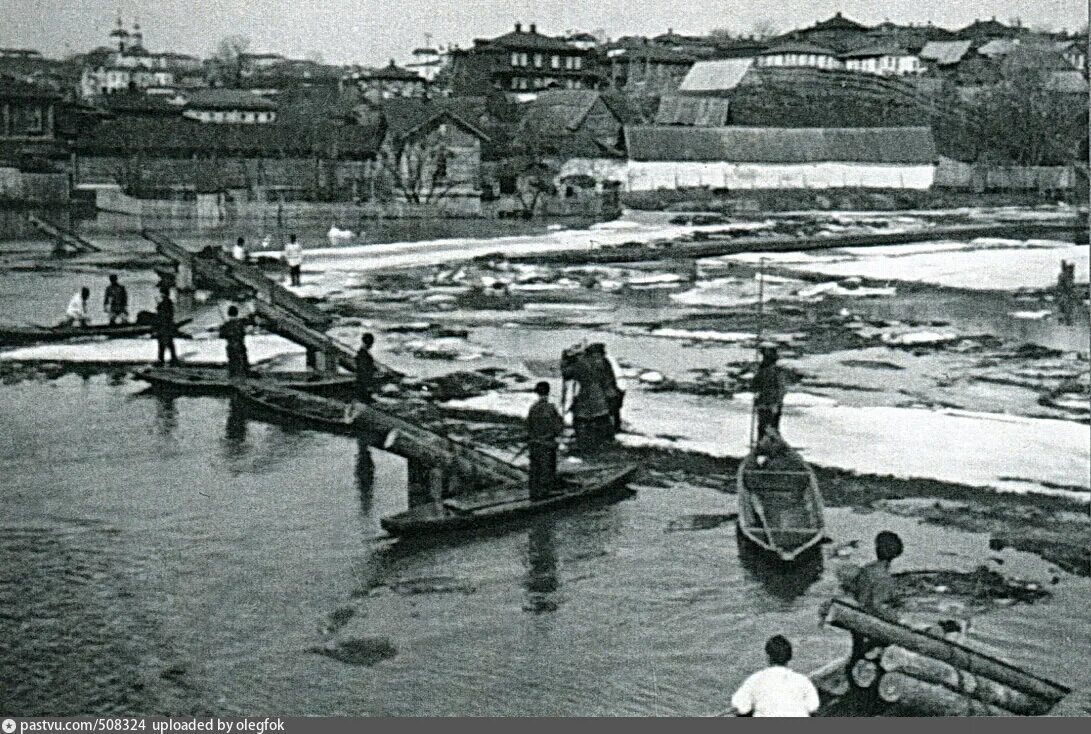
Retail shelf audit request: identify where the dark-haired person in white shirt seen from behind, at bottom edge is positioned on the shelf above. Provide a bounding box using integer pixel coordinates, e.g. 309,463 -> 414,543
731,635 -> 818,717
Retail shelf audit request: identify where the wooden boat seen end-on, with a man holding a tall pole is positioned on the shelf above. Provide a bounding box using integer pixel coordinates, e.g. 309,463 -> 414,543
736,440 -> 825,562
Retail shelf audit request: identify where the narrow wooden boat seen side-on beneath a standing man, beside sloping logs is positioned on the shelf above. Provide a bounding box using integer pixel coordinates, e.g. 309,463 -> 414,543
380,465 -> 637,538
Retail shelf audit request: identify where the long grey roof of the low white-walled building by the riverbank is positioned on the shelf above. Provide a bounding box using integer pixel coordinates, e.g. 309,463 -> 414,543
625,125 -> 936,164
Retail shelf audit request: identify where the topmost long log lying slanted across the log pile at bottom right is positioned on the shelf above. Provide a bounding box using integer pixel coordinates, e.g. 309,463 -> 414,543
826,600 -> 1068,706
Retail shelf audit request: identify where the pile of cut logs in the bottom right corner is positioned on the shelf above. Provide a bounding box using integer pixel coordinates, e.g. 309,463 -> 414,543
826,600 -> 1068,717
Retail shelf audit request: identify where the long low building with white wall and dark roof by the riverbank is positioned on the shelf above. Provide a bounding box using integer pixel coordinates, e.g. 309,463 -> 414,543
613,125 -> 937,191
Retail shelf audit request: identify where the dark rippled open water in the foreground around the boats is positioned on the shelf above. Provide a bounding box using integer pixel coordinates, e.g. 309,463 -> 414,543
0,376 -> 1091,715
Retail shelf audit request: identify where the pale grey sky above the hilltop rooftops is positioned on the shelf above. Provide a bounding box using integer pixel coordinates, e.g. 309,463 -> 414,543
0,0 -> 1088,65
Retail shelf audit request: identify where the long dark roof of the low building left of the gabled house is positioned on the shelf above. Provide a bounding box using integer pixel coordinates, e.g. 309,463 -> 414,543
75,117 -> 380,158
